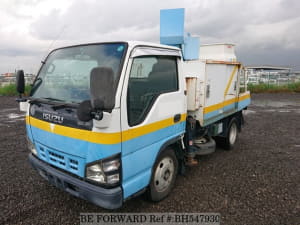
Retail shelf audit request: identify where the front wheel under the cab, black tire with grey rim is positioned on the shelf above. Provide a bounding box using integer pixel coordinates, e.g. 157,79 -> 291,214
148,148 -> 178,202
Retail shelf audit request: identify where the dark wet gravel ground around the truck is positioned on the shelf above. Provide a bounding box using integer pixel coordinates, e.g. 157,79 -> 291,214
0,94 -> 300,225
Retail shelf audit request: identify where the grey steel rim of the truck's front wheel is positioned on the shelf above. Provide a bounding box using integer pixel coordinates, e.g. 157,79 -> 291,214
154,157 -> 175,192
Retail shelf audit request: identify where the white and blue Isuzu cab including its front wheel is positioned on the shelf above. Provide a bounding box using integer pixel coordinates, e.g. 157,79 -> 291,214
22,42 -> 186,208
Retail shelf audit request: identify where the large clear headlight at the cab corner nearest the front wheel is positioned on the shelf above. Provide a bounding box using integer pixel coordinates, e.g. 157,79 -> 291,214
86,154 -> 121,185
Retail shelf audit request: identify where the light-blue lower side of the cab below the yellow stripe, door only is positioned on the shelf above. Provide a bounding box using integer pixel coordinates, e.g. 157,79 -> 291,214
122,122 -> 185,198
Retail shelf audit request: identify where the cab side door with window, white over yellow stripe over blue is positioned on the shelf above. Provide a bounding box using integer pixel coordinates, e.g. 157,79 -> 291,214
121,48 -> 186,198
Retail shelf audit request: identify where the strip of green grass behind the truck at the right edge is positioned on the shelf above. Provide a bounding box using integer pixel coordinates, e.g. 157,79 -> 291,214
248,82 -> 300,93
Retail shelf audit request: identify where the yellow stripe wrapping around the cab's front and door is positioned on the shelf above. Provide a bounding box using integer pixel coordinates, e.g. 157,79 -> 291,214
26,114 -> 186,144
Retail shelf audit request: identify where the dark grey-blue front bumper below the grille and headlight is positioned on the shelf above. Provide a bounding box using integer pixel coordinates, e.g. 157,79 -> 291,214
29,153 -> 123,209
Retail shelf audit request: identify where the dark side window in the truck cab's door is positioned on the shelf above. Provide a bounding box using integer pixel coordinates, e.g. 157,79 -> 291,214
127,56 -> 178,126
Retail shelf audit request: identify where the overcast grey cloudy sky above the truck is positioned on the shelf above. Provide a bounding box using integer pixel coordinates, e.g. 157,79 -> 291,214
0,0 -> 300,74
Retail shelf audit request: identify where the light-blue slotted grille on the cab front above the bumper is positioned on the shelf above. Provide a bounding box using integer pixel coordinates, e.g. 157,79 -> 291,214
37,144 -> 84,177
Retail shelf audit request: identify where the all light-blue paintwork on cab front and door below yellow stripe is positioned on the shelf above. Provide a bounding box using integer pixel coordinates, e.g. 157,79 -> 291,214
27,118 -> 185,198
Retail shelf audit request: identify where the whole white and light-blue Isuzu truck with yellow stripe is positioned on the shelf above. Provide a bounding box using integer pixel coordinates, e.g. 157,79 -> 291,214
17,9 -> 250,209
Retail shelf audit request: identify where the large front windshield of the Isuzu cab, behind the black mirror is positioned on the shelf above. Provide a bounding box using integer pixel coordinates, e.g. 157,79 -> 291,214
31,43 -> 126,103
